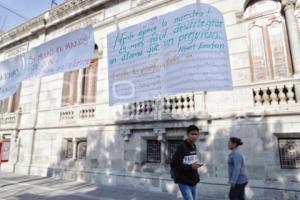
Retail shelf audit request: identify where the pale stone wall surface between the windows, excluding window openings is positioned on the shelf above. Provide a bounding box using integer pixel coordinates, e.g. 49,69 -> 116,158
0,0 -> 300,200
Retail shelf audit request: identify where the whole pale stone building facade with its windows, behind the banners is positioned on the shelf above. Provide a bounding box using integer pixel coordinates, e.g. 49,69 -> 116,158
0,0 -> 300,200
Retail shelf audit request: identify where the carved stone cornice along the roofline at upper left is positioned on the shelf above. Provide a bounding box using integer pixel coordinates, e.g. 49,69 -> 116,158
0,0 -> 171,53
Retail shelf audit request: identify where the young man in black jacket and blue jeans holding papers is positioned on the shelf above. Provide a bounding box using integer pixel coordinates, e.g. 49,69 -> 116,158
171,125 -> 202,200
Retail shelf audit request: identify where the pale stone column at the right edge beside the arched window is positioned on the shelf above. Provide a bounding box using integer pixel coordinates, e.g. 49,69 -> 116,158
282,0 -> 300,74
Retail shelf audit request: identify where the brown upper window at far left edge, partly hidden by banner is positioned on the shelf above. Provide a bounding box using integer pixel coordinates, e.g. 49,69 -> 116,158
0,86 -> 21,113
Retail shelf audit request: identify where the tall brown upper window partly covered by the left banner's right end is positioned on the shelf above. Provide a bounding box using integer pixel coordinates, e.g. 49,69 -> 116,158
62,45 -> 99,106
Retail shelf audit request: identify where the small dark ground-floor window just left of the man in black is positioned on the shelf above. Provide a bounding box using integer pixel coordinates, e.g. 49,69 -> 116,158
147,140 -> 161,163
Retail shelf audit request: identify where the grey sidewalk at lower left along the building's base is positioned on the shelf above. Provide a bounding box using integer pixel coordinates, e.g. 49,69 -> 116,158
0,172 -> 179,200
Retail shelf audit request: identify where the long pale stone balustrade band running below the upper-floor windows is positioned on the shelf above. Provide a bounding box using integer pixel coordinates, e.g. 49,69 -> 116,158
37,79 -> 300,127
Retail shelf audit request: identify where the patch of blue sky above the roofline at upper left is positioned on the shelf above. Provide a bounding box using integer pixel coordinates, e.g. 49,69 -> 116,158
0,0 -> 64,32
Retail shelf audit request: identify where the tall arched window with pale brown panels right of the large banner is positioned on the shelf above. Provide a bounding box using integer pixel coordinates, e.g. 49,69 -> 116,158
244,0 -> 292,81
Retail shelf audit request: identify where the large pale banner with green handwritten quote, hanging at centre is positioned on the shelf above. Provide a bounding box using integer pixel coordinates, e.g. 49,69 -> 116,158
108,4 -> 232,105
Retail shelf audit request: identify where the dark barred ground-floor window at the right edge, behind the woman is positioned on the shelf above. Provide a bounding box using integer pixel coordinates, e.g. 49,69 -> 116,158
278,138 -> 300,169
